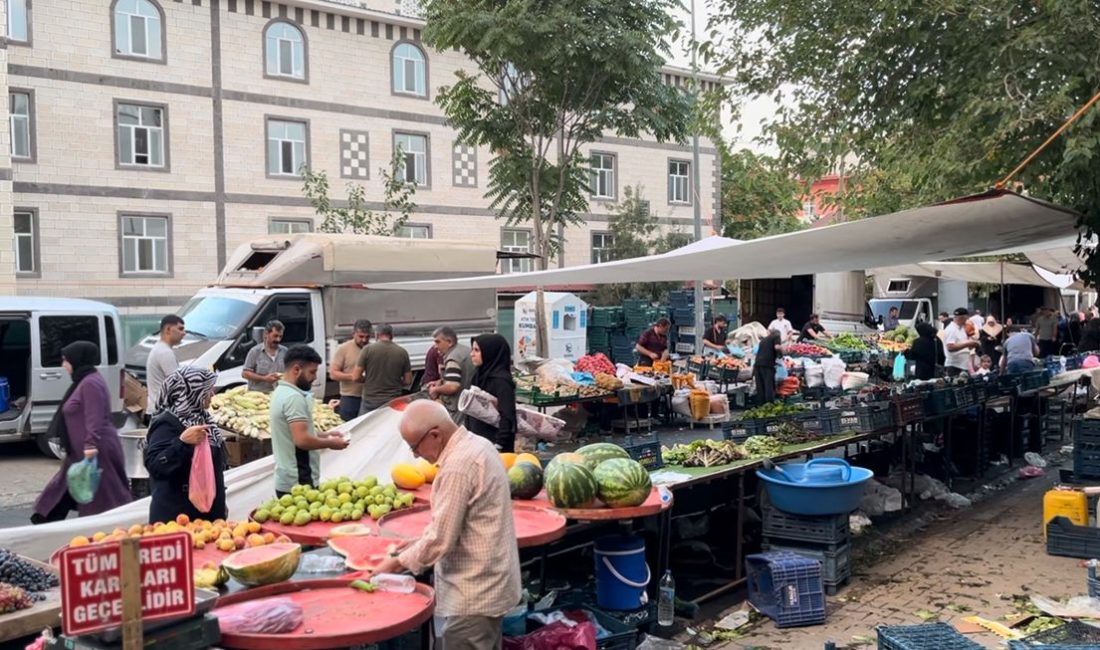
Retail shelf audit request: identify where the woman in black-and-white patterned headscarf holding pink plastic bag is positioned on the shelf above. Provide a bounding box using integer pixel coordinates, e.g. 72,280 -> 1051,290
145,366 -> 227,522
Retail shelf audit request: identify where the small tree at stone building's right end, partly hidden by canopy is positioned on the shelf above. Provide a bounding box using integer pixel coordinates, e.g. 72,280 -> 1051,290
590,186 -> 691,305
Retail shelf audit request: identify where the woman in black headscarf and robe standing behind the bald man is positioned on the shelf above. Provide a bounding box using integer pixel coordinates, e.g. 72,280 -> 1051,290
466,334 -> 516,452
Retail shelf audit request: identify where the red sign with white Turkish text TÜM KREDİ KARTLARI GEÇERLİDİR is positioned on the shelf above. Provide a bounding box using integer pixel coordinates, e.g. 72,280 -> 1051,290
61,532 -> 195,636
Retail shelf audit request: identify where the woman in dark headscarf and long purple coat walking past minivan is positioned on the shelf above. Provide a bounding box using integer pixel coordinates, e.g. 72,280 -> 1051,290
31,341 -> 131,524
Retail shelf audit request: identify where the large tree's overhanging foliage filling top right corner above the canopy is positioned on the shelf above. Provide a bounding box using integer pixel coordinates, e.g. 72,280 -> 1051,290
701,0 -> 1100,279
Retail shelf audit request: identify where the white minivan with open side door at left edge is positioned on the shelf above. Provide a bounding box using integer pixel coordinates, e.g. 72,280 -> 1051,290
0,296 -> 125,455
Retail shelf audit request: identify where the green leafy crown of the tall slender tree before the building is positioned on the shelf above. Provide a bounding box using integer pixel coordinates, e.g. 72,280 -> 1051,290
424,0 -> 692,268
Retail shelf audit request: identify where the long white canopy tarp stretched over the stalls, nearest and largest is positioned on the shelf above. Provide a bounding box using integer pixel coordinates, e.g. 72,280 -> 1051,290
371,190 -> 1077,291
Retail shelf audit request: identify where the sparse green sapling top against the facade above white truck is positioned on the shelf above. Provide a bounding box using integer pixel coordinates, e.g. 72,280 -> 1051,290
301,147 -> 416,236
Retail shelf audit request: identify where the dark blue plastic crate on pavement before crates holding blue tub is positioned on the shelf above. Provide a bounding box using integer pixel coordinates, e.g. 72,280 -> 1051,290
745,553 -> 825,628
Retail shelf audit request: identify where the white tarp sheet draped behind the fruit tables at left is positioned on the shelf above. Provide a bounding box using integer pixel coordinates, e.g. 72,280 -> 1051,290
0,408 -> 414,562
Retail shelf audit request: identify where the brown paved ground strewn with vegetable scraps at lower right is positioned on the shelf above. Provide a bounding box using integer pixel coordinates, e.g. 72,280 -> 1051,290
704,470 -> 1086,650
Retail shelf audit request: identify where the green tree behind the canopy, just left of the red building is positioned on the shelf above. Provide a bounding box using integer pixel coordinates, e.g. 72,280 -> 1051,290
718,146 -> 804,240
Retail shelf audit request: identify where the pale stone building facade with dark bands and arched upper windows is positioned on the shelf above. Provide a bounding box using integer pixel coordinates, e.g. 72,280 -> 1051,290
0,0 -> 719,311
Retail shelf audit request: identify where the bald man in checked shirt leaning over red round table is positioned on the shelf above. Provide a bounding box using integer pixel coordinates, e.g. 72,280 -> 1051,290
374,399 -> 520,650
